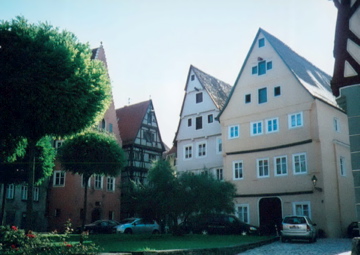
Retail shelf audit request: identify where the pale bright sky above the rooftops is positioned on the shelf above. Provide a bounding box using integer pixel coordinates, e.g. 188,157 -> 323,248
0,0 -> 337,147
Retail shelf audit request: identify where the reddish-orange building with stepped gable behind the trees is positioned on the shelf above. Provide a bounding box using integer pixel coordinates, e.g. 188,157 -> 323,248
47,45 -> 122,231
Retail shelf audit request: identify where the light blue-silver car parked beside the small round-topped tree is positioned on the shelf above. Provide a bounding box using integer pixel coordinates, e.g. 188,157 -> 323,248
114,218 -> 160,234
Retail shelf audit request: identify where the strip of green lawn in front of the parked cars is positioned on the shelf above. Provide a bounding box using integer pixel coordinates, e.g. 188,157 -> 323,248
73,234 -> 270,252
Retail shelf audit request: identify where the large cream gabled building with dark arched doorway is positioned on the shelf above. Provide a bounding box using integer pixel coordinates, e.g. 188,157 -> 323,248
219,29 -> 355,237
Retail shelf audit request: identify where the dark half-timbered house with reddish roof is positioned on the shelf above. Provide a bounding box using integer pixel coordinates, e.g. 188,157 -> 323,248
116,100 -> 165,218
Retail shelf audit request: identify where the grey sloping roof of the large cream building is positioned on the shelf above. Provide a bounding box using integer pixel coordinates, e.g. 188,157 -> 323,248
218,28 -> 340,117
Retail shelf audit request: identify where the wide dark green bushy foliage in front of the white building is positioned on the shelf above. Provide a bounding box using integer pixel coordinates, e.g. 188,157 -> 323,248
127,161 -> 236,232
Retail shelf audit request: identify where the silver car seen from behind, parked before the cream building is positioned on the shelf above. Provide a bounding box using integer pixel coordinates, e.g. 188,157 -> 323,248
281,216 -> 317,242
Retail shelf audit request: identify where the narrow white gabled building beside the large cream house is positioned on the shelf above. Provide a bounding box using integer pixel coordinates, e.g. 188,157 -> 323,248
174,66 -> 231,180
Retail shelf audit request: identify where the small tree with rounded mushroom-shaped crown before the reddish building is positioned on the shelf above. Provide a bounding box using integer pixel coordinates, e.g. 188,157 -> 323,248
58,130 -> 125,228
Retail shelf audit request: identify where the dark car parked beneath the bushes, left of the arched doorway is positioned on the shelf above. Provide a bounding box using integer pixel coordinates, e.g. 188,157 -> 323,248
181,214 -> 260,235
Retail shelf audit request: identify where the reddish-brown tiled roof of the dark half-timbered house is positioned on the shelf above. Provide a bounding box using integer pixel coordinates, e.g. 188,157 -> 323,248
116,100 -> 152,145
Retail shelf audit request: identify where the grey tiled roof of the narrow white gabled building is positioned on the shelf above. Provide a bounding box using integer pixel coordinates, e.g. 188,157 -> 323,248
185,65 -> 231,110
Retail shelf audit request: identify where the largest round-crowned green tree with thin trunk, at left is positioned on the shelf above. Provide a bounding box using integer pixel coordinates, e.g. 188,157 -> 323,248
0,17 -> 111,230
